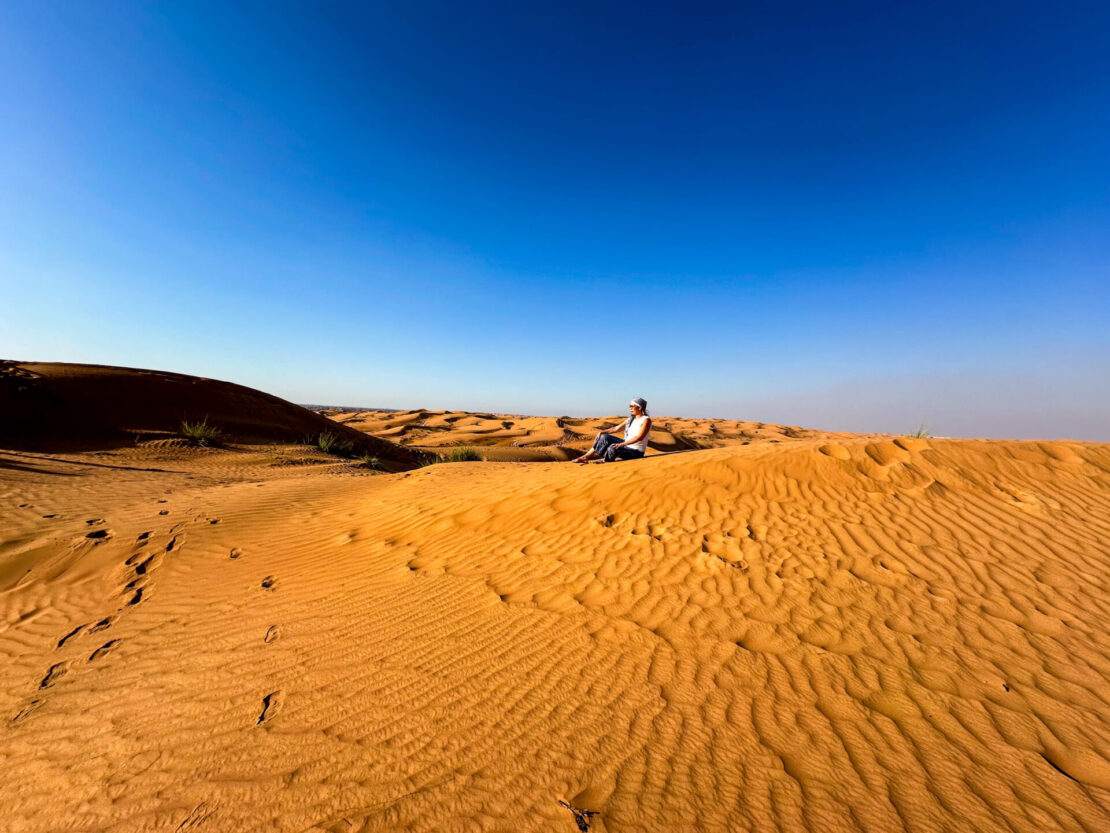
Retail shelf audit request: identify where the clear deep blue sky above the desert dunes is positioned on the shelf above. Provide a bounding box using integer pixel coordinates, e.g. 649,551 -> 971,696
0,0 -> 1110,440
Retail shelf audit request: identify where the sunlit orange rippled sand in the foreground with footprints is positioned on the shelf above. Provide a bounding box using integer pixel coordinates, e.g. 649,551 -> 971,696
0,440 -> 1110,833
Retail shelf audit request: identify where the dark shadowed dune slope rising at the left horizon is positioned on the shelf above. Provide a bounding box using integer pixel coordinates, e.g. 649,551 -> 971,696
0,361 -> 416,469
